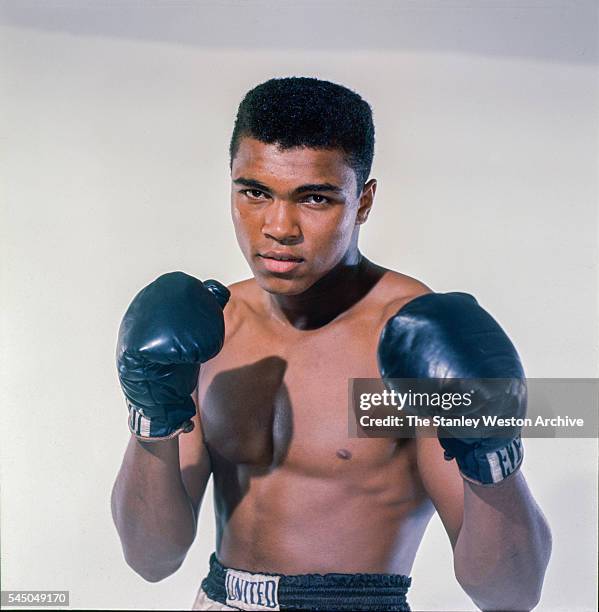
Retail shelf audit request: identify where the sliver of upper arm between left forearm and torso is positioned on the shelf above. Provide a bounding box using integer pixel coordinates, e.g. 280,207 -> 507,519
179,389 -> 212,518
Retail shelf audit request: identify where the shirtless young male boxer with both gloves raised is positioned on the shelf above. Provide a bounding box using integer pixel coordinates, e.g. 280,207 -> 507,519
112,78 -> 551,610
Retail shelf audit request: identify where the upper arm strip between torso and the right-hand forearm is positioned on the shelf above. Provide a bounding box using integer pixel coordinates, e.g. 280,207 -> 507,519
416,431 -> 464,547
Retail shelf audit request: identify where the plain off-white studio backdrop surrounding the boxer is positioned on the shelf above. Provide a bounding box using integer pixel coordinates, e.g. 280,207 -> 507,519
0,0 -> 599,612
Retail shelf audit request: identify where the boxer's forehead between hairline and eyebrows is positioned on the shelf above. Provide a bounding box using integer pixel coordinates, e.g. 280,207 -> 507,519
232,137 -> 355,188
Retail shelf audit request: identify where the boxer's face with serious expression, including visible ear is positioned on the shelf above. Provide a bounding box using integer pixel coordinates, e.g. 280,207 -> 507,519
231,137 -> 376,295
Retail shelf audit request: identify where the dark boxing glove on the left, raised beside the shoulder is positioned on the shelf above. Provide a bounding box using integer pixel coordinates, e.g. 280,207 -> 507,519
116,272 -> 230,442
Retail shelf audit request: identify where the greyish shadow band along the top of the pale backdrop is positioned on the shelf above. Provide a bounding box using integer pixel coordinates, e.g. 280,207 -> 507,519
0,0 -> 599,64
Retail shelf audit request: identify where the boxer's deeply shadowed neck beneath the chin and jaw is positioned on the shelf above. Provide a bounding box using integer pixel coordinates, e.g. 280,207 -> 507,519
268,249 -> 381,330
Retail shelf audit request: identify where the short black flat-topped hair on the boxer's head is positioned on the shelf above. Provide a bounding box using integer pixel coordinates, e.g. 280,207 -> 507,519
229,77 -> 374,195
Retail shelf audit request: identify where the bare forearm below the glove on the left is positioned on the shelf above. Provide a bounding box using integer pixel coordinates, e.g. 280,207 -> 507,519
111,436 -> 196,582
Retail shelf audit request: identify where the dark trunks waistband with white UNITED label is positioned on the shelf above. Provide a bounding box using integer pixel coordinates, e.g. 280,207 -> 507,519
202,553 -> 412,612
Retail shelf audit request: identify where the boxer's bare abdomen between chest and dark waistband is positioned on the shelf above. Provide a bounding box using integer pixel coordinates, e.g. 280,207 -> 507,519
214,441 -> 433,575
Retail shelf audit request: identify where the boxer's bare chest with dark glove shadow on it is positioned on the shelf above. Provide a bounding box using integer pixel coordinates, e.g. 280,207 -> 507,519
198,320 -> 395,470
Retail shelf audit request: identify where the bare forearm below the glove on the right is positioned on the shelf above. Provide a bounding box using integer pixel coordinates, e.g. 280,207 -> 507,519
454,472 -> 551,610
